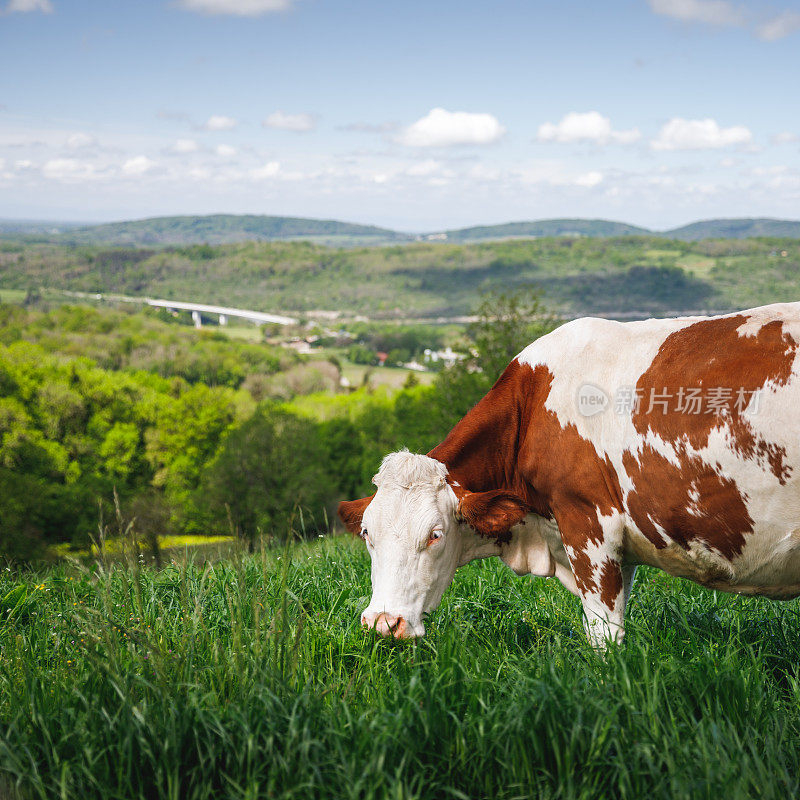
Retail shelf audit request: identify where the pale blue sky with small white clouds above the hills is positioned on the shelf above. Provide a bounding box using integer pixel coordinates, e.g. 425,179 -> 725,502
0,0 -> 800,232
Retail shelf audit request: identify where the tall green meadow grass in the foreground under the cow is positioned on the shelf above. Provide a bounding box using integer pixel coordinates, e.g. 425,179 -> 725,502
0,538 -> 800,800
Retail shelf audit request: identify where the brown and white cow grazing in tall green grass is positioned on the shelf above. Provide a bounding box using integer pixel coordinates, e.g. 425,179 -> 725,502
339,303 -> 800,646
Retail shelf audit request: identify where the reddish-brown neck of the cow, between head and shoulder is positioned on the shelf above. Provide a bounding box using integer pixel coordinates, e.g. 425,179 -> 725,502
428,359 -> 540,509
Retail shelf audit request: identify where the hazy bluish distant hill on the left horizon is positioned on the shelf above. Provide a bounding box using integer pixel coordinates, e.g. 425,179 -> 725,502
53,214 -> 411,246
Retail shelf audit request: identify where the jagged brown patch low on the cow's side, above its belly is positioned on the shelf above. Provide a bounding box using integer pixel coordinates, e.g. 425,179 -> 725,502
622,445 -> 753,559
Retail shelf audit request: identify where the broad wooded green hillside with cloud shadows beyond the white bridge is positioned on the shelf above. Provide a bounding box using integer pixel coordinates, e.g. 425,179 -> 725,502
0,236 -> 800,319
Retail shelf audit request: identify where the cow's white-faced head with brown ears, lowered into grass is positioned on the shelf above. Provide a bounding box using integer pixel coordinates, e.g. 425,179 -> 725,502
339,451 -> 528,638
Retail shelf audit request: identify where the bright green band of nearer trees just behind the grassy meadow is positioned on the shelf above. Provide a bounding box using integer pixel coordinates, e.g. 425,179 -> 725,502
0,296 -> 553,559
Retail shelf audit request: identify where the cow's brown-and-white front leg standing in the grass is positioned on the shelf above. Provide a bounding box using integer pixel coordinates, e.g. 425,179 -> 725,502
558,510 -> 636,650
